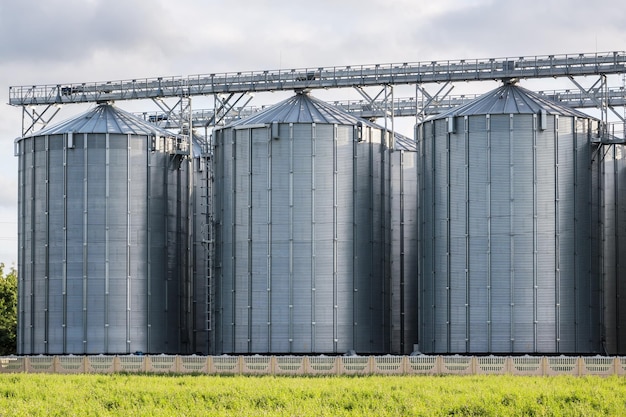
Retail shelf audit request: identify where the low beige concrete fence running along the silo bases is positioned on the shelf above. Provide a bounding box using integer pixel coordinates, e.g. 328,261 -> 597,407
0,355 -> 626,376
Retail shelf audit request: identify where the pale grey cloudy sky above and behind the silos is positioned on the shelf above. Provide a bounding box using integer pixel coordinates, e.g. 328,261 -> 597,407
0,0 -> 626,265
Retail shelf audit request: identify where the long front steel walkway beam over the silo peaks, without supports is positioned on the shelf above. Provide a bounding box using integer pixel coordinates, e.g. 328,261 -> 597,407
9,52 -> 626,106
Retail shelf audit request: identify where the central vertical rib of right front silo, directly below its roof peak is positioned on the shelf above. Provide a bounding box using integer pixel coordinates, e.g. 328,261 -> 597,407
508,114 -> 515,352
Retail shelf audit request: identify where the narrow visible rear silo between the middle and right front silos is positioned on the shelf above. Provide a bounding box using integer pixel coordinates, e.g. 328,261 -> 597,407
388,135 -> 418,354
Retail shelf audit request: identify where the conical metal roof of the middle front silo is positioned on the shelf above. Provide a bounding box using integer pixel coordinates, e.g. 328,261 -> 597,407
228,92 -> 370,127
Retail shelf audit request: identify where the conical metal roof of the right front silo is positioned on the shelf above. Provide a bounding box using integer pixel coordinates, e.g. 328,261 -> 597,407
430,83 -> 590,120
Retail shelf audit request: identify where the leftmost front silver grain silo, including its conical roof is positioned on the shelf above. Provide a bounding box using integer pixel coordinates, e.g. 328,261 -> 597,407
16,104 -> 189,354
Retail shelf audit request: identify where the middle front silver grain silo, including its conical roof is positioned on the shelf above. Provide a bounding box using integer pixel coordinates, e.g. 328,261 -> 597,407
214,93 -> 390,353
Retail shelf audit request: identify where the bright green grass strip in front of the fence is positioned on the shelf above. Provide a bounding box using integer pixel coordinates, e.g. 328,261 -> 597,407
0,374 -> 626,417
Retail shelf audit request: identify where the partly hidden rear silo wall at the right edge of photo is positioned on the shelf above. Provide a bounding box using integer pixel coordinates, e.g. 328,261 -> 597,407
594,141 -> 626,355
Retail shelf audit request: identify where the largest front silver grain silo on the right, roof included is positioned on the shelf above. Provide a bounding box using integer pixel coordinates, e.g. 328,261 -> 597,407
418,83 -> 600,353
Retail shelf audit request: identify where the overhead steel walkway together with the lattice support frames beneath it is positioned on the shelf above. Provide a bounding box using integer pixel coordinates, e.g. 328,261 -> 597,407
9,51 -> 626,141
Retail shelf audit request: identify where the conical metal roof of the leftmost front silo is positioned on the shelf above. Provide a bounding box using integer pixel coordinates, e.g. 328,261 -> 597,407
26,104 -> 176,136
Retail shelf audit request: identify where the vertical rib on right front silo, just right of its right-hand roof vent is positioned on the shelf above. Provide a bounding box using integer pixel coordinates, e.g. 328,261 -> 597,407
554,115 -> 561,352
